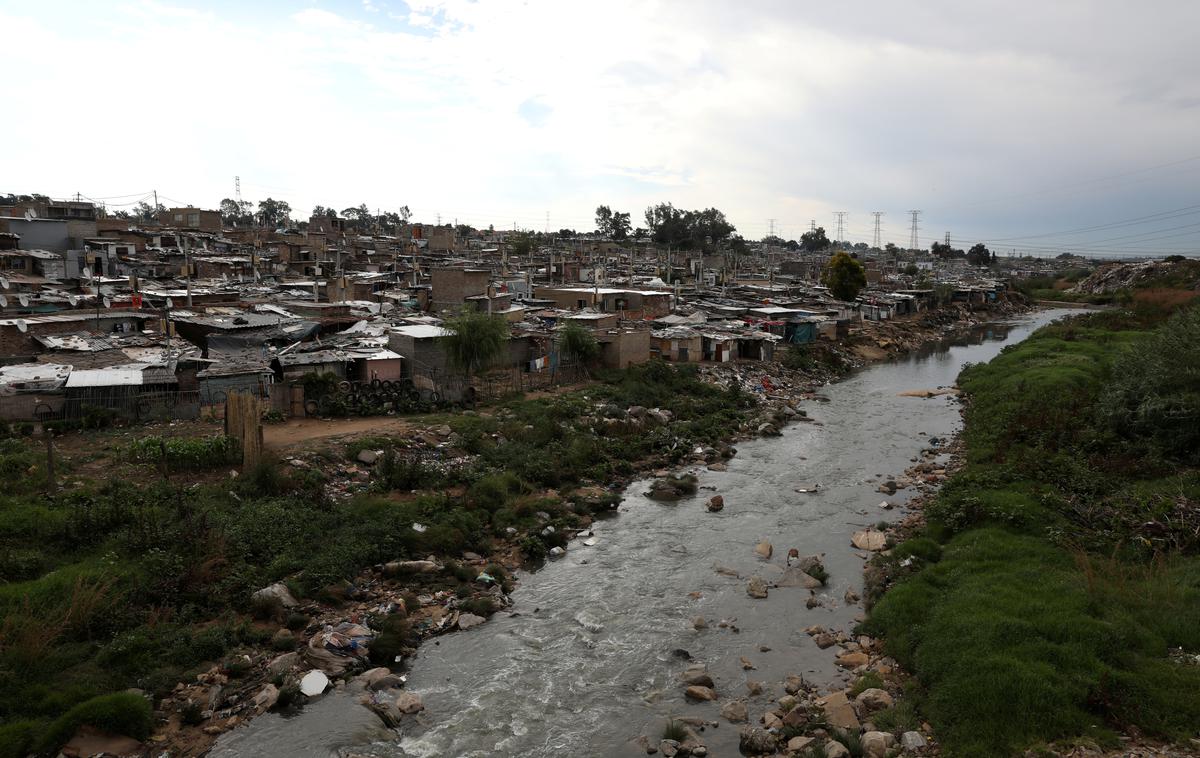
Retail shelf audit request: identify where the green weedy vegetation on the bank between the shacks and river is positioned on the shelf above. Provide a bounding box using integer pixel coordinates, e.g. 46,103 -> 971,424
0,362 -> 754,758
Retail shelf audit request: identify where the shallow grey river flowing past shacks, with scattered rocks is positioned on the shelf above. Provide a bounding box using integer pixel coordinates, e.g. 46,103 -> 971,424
212,311 -> 1069,758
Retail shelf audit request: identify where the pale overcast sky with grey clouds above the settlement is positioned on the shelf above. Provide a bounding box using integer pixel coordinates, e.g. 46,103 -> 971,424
0,0 -> 1200,257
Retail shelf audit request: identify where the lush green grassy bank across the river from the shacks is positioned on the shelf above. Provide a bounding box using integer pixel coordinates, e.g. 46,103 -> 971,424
865,307 -> 1200,756
